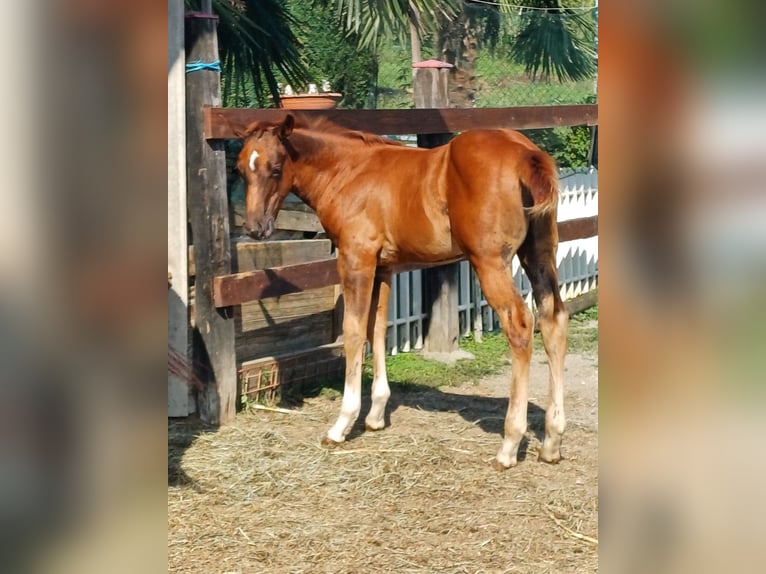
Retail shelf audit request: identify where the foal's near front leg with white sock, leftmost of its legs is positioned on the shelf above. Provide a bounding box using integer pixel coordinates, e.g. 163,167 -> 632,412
322,256 -> 375,446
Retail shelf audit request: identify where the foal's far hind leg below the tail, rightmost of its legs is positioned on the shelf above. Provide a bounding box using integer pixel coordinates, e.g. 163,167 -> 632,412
518,214 -> 569,463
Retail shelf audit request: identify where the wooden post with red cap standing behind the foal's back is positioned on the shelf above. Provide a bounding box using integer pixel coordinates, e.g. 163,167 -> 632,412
412,60 -> 471,362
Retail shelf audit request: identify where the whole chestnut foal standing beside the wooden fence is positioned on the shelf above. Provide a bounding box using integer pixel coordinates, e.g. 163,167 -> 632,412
235,115 -> 568,469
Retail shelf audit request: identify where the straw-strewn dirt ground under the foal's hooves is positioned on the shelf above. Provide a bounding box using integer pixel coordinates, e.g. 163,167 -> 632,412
168,352 -> 598,574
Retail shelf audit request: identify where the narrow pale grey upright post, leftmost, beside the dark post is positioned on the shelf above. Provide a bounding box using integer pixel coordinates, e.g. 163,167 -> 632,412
168,0 -> 194,417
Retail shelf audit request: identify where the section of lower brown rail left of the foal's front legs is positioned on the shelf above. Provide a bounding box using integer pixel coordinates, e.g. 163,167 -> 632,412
213,259 -> 340,307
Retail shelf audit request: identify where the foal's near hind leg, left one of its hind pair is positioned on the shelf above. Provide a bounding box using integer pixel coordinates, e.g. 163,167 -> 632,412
471,255 -> 534,470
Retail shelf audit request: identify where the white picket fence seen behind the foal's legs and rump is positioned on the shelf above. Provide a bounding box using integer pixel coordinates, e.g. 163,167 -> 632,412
387,169 -> 598,355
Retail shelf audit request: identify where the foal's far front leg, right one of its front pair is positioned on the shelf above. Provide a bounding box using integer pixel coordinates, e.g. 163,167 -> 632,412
364,268 -> 391,430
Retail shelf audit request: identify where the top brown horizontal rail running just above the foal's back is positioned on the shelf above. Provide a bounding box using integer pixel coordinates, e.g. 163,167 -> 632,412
204,104 -> 598,139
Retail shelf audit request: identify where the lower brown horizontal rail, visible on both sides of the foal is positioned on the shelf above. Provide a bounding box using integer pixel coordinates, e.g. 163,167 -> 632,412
213,215 -> 598,307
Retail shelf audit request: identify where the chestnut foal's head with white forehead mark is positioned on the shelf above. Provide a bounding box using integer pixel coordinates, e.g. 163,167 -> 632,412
235,115 -> 295,239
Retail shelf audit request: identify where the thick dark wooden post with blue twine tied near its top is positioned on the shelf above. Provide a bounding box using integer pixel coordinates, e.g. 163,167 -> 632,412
186,12 -> 237,424
